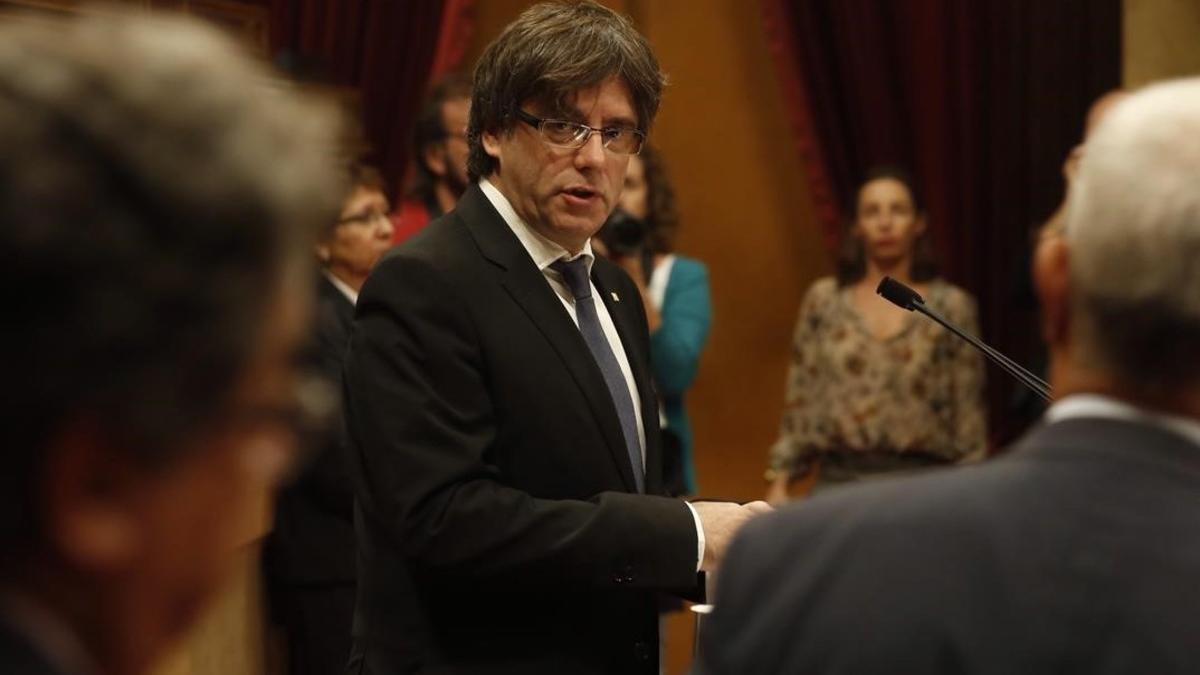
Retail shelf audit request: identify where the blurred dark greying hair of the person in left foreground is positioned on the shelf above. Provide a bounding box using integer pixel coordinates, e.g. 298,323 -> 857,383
0,13 -> 341,550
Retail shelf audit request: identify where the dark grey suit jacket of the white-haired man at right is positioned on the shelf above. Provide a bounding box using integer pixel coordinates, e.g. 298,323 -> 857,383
700,418 -> 1200,675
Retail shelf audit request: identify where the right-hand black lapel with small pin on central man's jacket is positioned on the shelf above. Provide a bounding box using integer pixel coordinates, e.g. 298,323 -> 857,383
592,265 -> 662,494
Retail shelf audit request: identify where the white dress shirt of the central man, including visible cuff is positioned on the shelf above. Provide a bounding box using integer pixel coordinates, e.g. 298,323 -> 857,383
479,178 -> 704,571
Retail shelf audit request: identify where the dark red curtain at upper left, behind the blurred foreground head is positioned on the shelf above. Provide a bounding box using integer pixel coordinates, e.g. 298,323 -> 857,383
269,0 -> 472,196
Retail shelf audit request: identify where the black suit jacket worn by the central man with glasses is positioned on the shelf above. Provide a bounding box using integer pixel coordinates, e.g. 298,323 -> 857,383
346,186 -> 696,674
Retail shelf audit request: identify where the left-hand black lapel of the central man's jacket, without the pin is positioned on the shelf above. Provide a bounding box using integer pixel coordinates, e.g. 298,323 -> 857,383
456,185 -> 637,492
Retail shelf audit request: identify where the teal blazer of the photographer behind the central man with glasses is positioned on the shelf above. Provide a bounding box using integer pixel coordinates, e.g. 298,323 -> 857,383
650,255 -> 713,494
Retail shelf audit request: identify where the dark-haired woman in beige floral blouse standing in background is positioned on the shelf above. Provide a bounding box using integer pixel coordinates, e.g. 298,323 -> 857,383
767,168 -> 986,502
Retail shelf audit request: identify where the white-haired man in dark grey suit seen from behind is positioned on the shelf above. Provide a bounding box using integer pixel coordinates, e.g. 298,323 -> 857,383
700,79 -> 1200,675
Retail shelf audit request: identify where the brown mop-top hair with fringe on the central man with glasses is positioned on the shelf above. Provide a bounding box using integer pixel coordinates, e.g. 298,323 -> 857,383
467,1 -> 664,181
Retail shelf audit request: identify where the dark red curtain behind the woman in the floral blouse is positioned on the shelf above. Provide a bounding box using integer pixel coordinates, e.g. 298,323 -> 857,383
762,0 -> 1121,442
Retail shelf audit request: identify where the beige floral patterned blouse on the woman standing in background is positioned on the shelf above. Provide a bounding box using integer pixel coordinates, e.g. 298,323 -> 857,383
770,277 -> 986,471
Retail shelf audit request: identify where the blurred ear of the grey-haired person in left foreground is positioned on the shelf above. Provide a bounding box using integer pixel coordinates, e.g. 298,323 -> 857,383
41,423 -> 142,572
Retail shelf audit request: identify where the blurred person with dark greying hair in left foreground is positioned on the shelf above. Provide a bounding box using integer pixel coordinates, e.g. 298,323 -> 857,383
0,9 -> 335,675
